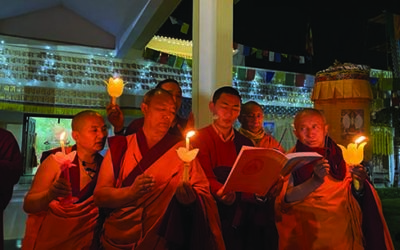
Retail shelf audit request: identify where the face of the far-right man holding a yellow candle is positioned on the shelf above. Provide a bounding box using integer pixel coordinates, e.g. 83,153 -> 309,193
294,114 -> 328,148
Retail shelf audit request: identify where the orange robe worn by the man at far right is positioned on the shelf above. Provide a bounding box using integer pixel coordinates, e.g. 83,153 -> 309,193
275,167 -> 393,250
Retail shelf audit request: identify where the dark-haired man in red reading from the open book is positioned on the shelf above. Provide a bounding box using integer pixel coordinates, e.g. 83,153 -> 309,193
193,86 -> 277,250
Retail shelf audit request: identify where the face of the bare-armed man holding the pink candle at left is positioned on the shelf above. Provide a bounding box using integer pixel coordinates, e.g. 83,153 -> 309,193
72,115 -> 108,154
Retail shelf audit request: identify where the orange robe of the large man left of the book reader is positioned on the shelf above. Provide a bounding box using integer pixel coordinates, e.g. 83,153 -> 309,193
101,134 -> 225,250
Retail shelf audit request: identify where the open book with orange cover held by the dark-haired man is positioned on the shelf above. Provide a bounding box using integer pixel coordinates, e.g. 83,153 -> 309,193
223,146 -> 323,196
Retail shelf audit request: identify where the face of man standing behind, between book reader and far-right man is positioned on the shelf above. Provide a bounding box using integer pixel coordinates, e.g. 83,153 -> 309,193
239,104 -> 264,133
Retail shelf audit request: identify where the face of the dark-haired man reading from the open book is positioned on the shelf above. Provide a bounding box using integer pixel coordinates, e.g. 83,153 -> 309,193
209,93 -> 240,129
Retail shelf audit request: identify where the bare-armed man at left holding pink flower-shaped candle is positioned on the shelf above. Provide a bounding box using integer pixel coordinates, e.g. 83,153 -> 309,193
22,110 -> 107,250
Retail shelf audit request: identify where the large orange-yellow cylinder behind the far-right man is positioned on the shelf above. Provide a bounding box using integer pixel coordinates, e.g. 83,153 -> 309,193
311,63 -> 373,161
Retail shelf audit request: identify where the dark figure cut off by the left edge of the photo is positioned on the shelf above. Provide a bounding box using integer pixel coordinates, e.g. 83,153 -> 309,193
0,128 -> 23,249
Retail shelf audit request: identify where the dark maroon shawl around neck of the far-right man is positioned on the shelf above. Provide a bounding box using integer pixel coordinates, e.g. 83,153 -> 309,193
293,137 -> 346,186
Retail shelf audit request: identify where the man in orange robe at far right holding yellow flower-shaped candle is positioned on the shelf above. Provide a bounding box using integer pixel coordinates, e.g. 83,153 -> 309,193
275,108 -> 393,250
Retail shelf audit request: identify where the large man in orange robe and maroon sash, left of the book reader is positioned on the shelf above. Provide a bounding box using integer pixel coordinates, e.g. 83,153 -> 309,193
94,89 -> 224,250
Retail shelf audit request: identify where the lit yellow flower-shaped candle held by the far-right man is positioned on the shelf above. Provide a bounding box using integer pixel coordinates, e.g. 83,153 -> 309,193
338,136 -> 367,190
